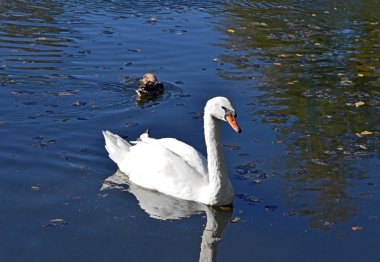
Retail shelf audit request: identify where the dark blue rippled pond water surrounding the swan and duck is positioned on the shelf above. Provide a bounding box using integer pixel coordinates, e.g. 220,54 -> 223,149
0,0 -> 380,261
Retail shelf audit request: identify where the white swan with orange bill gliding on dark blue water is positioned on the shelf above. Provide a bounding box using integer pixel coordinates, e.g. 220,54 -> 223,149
103,97 -> 241,206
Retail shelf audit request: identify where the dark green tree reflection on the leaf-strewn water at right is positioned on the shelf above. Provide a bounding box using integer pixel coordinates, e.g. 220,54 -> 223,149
219,1 -> 380,229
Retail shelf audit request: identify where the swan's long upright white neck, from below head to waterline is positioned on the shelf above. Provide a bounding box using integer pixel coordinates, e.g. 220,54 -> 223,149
204,111 -> 233,205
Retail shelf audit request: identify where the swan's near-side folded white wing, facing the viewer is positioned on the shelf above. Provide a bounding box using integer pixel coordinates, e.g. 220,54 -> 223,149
117,142 -> 208,200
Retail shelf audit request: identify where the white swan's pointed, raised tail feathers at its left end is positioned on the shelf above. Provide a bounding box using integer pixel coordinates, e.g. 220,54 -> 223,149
102,130 -> 132,163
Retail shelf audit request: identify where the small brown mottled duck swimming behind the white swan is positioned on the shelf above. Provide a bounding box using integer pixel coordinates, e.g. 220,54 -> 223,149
136,73 -> 165,98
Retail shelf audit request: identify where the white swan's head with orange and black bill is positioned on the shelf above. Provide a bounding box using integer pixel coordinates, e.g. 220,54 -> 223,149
205,96 -> 241,133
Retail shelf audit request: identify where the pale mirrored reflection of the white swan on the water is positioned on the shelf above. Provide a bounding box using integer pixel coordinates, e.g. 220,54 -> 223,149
100,170 -> 232,262
